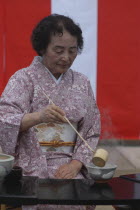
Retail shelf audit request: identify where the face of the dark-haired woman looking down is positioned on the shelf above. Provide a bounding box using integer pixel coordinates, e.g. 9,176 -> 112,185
43,31 -> 78,78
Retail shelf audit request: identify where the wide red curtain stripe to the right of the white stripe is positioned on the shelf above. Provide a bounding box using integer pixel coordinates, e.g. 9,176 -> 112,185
97,0 -> 140,139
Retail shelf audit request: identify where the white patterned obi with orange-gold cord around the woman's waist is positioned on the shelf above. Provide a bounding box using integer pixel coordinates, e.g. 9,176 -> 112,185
34,123 -> 77,153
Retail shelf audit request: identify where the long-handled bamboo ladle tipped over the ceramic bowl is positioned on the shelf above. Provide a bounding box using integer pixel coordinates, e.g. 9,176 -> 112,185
40,88 -> 108,167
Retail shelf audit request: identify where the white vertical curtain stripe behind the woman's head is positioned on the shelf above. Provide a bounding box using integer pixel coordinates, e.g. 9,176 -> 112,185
51,0 -> 98,95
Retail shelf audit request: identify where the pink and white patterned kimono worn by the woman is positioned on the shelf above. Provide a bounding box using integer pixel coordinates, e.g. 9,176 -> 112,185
0,56 -> 100,209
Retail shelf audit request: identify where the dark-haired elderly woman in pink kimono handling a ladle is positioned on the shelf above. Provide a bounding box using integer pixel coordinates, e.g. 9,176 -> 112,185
0,14 -> 100,209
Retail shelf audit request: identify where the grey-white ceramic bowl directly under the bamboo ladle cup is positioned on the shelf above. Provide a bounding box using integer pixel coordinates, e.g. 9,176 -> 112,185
87,163 -> 117,182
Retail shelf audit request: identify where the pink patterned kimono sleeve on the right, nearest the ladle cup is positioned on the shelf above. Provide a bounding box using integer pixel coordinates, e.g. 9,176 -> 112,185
72,79 -> 100,166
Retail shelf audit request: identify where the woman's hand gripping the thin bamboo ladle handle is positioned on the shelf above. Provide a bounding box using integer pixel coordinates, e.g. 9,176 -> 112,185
39,104 -> 66,123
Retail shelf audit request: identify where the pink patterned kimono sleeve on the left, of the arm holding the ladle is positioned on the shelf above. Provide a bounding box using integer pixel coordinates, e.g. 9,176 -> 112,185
0,70 -> 32,155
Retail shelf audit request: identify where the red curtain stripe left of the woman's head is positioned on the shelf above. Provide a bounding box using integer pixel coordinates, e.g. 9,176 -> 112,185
0,0 -> 51,94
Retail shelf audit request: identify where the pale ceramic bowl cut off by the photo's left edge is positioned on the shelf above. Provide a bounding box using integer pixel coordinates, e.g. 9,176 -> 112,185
0,153 -> 15,181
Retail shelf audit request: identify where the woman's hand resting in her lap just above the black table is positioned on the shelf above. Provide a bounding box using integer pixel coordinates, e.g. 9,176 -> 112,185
55,160 -> 82,179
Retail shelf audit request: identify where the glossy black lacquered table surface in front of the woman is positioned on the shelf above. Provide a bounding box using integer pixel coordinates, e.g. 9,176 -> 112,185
0,174 -> 140,205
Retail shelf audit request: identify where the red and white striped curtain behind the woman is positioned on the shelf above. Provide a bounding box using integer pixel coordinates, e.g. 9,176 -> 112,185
0,0 -> 140,140
